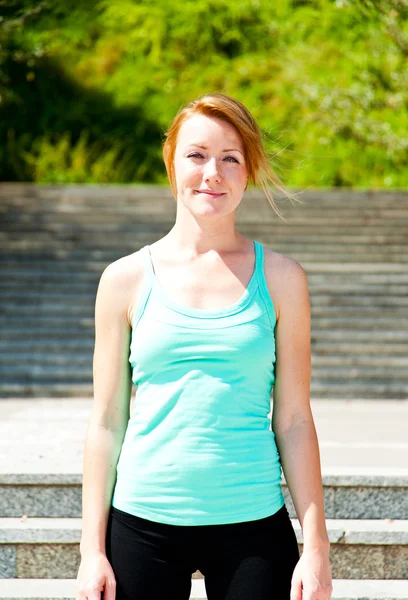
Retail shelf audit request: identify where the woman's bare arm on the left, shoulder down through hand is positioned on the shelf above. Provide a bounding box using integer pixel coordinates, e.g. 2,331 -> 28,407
77,257 -> 141,600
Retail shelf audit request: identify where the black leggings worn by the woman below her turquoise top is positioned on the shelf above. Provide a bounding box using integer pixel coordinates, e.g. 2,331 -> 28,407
106,506 -> 299,600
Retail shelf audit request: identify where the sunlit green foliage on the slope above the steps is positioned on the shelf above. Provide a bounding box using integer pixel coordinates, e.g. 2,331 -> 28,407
0,0 -> 408,187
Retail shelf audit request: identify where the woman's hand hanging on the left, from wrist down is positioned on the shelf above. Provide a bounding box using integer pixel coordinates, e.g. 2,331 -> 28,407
76,554 -> 116,600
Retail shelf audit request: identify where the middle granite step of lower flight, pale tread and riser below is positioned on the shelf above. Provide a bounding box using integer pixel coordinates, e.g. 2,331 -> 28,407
0,518 -> 408,579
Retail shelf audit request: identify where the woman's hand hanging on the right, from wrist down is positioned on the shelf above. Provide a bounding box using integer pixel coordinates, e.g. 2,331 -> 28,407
290,550 -> 333,600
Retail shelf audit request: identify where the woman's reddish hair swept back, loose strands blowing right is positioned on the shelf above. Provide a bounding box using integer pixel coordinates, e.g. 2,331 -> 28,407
163,93 -> 294,216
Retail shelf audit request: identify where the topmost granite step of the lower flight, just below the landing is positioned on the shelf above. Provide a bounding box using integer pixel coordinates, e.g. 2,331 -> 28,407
0,474 -> 408,519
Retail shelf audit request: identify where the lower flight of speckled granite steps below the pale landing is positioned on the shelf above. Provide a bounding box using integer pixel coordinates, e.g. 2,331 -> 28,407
0,474 -> 408,600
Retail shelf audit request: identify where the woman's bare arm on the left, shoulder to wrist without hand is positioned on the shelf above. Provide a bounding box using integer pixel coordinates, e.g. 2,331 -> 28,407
81,263 -> 132,553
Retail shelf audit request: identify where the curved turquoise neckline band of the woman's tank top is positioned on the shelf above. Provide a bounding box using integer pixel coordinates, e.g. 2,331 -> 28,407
145,240 -> 263,318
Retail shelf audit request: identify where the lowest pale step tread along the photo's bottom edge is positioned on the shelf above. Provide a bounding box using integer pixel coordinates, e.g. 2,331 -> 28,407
0,578 -> 408,600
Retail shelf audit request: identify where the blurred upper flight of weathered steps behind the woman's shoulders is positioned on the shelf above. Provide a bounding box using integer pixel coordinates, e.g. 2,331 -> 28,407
0,184 -> 408,399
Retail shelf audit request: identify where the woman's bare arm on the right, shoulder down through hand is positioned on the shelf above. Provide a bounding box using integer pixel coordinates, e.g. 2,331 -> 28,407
264,257 -> 331,599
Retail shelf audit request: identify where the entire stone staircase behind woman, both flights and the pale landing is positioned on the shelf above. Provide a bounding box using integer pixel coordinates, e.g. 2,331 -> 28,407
0,184 -> 408,600
